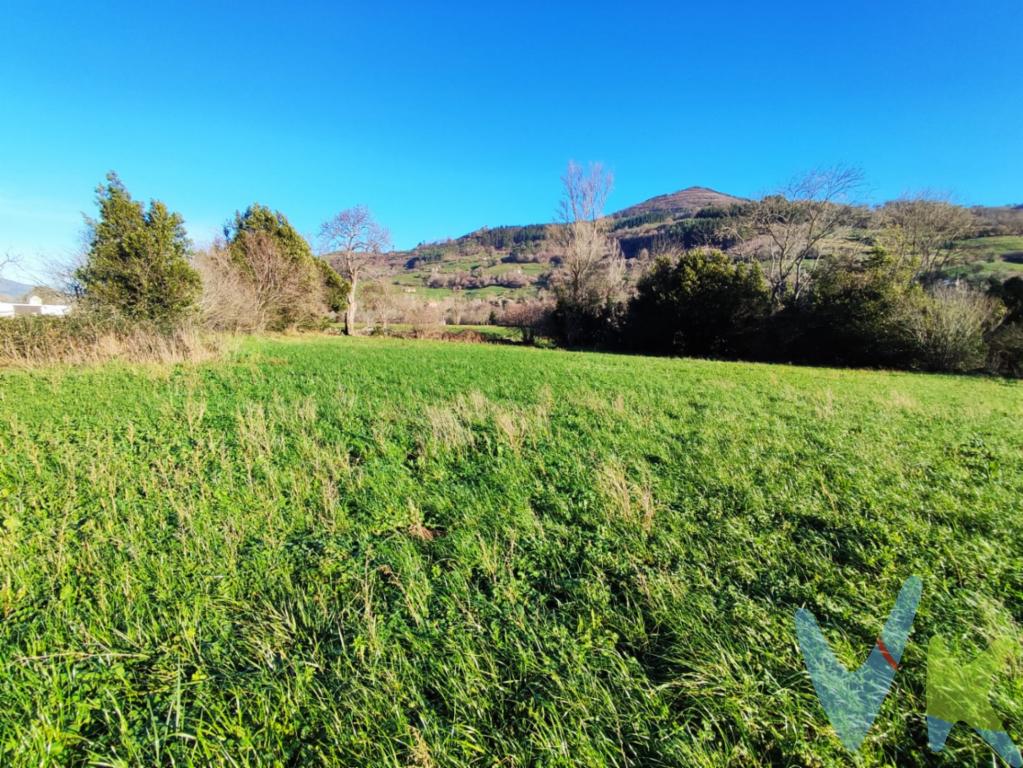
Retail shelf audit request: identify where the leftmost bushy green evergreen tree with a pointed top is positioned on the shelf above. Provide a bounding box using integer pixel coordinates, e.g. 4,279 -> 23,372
74,172 -> 199,325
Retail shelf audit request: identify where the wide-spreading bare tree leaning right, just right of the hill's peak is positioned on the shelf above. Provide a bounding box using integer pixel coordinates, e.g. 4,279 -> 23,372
746,166 -> 862,306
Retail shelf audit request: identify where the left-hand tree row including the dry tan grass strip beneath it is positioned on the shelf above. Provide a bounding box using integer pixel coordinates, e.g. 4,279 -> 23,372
0,172 -> 389,362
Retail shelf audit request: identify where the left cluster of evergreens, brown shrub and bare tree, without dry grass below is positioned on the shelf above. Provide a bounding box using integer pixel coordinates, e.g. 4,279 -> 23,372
71,173 -> 389,332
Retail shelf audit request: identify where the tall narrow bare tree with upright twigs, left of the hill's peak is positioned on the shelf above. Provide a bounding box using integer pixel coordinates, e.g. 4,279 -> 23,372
553,162 -> 625,341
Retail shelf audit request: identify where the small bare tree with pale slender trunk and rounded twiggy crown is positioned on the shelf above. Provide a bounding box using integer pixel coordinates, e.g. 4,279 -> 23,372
319,206 -> 391,335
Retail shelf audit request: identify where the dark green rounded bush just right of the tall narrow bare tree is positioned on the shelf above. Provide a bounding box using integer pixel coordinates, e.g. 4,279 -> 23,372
625,250 -> 769,357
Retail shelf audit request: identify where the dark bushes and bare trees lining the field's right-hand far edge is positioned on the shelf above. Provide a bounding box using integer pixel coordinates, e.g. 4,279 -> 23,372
540,163 -> 1023,376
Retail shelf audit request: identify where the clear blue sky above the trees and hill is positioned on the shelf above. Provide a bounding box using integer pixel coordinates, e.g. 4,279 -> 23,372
0,0 -> 1023,282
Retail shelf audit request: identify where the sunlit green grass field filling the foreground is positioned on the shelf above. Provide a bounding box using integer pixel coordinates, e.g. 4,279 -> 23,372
0,337 -> 1023,766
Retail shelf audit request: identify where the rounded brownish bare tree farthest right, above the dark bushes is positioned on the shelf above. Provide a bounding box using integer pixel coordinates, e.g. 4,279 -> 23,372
878,192 -> 977,279
